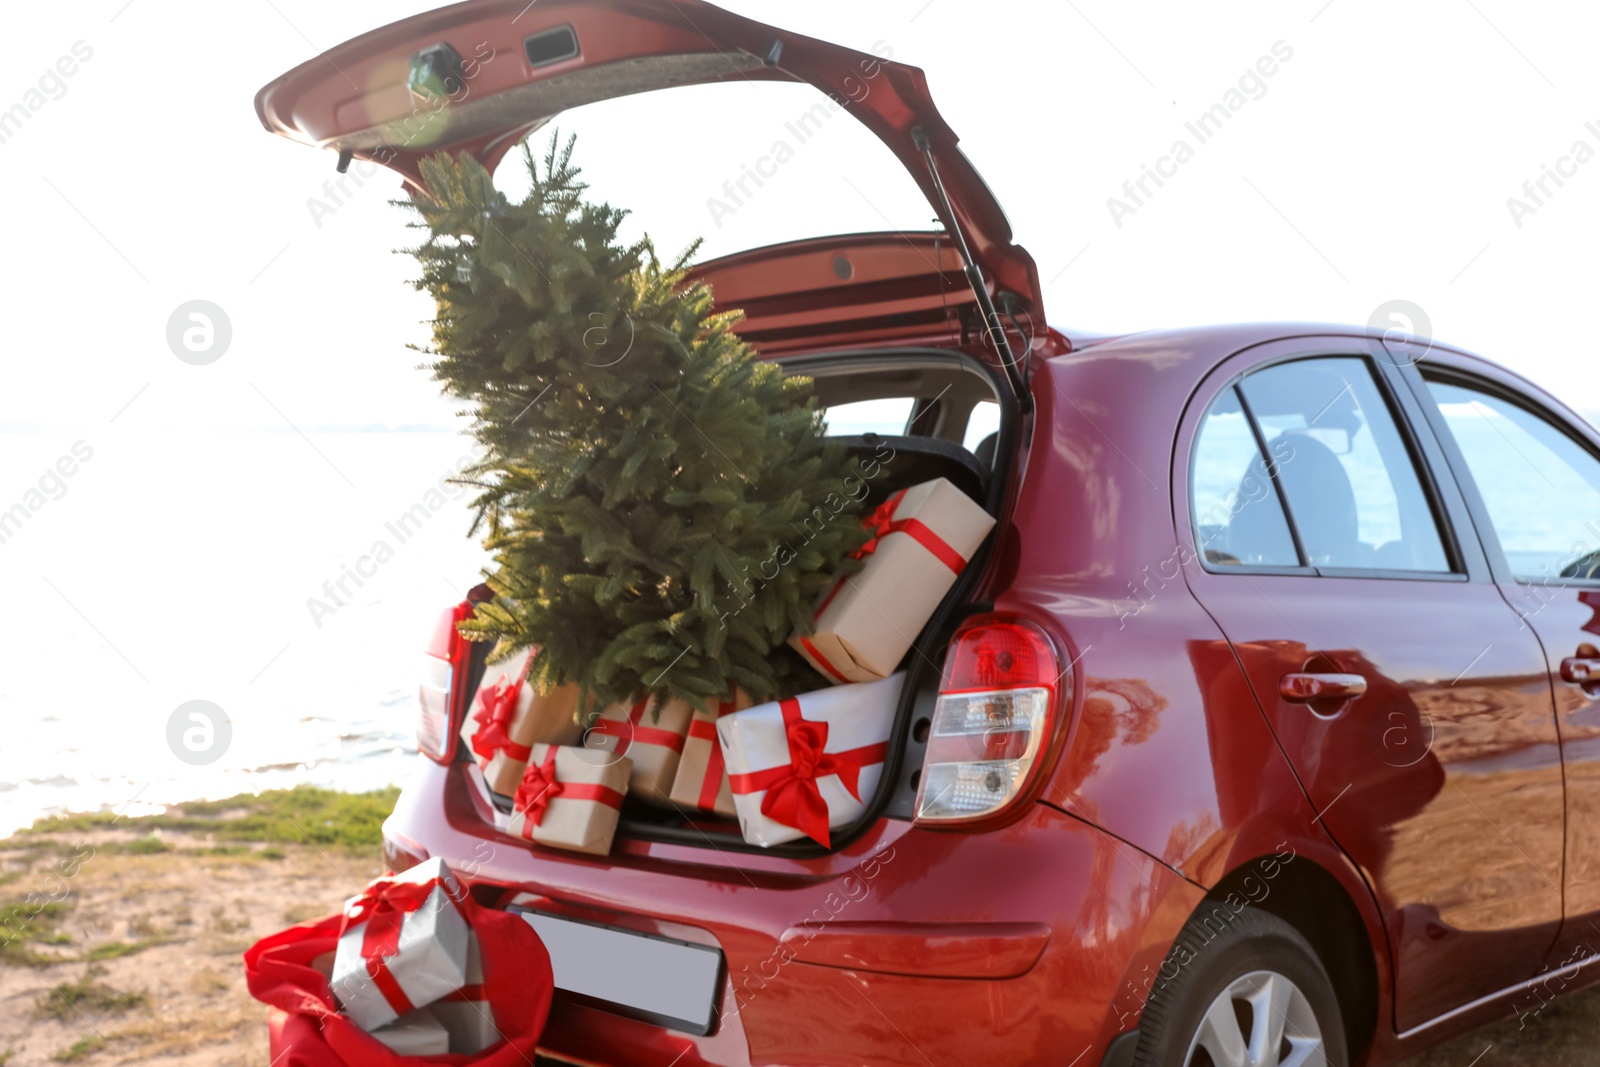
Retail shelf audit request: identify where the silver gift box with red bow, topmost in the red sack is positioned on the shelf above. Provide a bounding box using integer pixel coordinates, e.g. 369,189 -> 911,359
330,859 -> 470,1030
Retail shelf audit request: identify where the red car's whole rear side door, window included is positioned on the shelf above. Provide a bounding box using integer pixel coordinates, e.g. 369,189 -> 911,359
1174,339 -> 1563,1032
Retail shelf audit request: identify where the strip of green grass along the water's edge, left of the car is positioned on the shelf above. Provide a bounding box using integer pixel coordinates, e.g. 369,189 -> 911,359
22,785 -> 400,851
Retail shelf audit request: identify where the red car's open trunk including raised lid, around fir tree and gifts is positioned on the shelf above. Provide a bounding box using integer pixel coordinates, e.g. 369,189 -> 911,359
256,0 -> 1067,856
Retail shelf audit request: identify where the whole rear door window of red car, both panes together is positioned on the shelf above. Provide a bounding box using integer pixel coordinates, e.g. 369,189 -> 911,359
1190,357 -> 1451,573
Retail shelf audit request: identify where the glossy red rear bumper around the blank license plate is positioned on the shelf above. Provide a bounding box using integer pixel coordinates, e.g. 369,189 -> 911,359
384,757 -> 1187,1067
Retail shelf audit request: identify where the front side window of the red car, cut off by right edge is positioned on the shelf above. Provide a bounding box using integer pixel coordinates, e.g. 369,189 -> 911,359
1427,381 -> 1600,581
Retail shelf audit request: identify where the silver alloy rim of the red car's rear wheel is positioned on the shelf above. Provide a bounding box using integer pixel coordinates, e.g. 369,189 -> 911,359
1184,971 -> 1328,1067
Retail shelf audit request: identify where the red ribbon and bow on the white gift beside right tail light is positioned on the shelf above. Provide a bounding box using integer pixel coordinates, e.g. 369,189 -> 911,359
730,699 -> 888,848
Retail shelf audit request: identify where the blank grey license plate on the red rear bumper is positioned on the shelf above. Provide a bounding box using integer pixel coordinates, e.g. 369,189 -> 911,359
512,909 -> 723,1033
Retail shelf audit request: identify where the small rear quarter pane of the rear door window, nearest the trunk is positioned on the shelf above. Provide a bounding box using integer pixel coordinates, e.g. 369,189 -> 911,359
1189,387 -> 1299,568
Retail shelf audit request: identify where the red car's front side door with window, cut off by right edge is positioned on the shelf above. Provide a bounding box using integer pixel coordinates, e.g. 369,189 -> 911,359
1411,352 -> 1600,968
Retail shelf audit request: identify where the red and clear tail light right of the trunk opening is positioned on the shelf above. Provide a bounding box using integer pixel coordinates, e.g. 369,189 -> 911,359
917,616 -> 1072,825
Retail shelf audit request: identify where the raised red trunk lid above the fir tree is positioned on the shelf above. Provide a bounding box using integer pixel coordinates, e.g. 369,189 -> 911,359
256,0 -> 1045,334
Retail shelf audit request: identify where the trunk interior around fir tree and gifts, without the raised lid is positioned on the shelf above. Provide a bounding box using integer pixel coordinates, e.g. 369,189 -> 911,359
444,260 -> 1021,857
